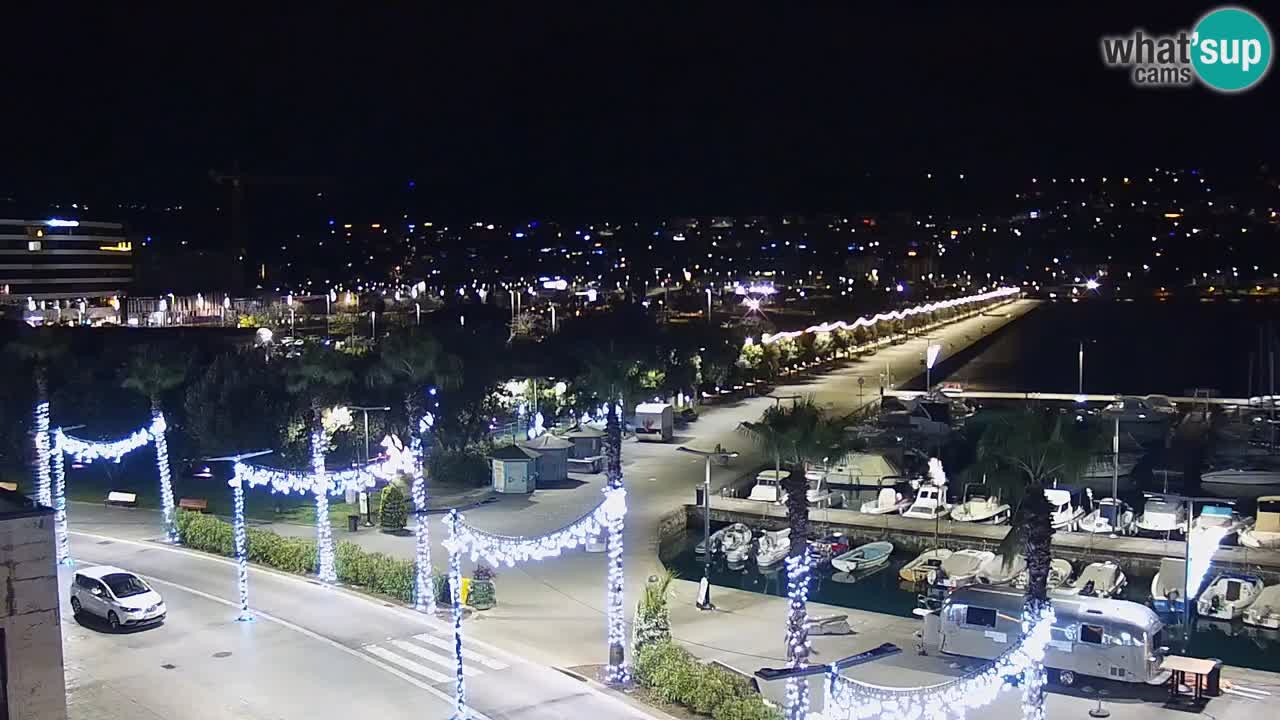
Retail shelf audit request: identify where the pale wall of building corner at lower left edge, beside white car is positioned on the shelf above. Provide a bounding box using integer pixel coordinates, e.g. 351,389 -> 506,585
0,511 -> 67,720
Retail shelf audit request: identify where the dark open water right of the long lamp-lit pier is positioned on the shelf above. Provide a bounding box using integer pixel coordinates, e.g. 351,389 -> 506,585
934,300 -> 1280,397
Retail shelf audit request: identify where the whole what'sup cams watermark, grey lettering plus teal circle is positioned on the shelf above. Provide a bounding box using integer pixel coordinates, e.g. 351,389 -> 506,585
1101,8 -> 1271,92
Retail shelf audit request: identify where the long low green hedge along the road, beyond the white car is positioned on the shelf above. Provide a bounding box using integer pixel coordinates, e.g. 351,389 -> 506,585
178,511 -> 447,605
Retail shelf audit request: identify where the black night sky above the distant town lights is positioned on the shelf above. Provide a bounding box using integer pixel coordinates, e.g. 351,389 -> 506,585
0,1 -> 1280,213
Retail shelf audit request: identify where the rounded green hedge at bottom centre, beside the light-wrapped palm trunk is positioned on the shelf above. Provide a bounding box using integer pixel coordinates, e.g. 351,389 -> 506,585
635,641 -> 782,720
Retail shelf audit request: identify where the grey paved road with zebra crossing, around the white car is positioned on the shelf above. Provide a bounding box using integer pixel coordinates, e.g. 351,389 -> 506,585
61,532 -> 644,720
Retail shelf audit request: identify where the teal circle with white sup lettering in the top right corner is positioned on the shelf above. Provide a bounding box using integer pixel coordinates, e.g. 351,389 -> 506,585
1192,8 -> 1271,92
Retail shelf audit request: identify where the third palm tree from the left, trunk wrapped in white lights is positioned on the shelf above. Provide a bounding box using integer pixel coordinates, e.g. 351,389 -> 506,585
284,343 -> 353,582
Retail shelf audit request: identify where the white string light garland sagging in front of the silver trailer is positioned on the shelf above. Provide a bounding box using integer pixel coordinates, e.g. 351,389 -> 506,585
826,609 -> 1053,720
